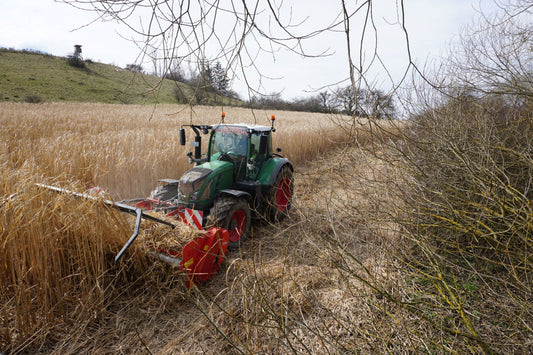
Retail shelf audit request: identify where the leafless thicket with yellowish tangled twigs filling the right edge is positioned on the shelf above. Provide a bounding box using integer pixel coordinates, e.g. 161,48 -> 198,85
386,1 -> 533,354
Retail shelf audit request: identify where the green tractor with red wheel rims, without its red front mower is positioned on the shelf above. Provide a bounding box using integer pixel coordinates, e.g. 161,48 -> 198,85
143,115 -> 294,248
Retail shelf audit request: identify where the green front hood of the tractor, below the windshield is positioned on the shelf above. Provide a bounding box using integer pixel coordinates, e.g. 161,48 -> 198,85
179,161 -> 233,207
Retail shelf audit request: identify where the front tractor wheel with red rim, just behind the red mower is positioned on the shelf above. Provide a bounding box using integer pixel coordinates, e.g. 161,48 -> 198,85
207,197 -> 252,249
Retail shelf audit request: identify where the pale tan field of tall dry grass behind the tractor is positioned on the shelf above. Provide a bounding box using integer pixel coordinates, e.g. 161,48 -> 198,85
0,103 -> 344,199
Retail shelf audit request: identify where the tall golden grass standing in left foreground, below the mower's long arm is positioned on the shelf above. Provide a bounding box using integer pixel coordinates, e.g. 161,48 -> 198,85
0,170 -> 154,351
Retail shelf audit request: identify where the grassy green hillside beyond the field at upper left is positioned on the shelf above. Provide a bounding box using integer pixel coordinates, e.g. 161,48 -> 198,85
0,49 -> 237,104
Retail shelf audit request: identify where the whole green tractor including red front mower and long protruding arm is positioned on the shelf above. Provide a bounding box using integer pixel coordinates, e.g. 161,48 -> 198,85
37,114 -> 293,287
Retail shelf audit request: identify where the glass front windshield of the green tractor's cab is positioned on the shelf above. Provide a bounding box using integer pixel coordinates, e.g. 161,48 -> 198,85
209,126 -> 248,160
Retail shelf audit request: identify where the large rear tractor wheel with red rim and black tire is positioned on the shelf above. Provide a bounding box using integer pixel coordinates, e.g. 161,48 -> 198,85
267,165 -> 294,222
